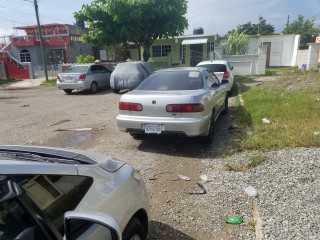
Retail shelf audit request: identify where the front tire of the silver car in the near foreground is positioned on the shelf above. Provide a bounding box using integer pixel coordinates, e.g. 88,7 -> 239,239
122,218 -> 147,240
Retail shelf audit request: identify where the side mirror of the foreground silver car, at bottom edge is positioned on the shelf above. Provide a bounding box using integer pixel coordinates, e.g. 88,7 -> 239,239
64,211 -> 122,240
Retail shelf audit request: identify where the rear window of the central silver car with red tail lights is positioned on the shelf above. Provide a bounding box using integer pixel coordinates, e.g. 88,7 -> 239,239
136,71 -> 203,91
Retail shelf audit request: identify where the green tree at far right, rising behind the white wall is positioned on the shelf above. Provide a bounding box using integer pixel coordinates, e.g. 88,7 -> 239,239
282,15 -> 320,49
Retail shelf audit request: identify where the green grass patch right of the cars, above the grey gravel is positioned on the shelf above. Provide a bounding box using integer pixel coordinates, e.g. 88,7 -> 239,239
237,69 -> 320,150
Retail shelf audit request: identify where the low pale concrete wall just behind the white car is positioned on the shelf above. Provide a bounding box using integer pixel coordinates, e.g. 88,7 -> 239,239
215,46 -> 267,76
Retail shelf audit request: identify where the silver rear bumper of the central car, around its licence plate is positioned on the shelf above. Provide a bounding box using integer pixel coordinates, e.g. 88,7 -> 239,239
116,115 -> 210,137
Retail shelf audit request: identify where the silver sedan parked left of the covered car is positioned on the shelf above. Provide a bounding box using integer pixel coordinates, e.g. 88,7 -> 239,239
57,64 -> 111,94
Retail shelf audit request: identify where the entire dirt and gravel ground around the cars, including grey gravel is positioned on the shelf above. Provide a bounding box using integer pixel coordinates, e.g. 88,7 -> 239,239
0,83 -> 320,239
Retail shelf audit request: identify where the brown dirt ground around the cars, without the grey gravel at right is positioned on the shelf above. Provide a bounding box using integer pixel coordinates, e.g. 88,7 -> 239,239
0,87 -> 250,239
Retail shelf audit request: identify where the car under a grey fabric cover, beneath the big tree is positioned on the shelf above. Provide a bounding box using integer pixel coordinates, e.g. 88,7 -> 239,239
110,62 -> 154,93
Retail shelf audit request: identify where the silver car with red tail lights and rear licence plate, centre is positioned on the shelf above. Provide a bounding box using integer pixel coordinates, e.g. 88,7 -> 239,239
117,67 -> 228,143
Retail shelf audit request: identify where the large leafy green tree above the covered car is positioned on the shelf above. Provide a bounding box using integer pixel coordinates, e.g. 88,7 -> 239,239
75,0 -> 188,61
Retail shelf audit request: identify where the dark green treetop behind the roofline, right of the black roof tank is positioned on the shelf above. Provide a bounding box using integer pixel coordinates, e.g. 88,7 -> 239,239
228,17 -> 274,35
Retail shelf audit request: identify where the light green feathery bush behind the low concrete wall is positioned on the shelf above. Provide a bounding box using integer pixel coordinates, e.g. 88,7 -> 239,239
223,28 -> 249,55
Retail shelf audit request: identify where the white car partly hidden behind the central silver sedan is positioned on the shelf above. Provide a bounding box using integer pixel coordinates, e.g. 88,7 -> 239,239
197,60 -> 234,92
